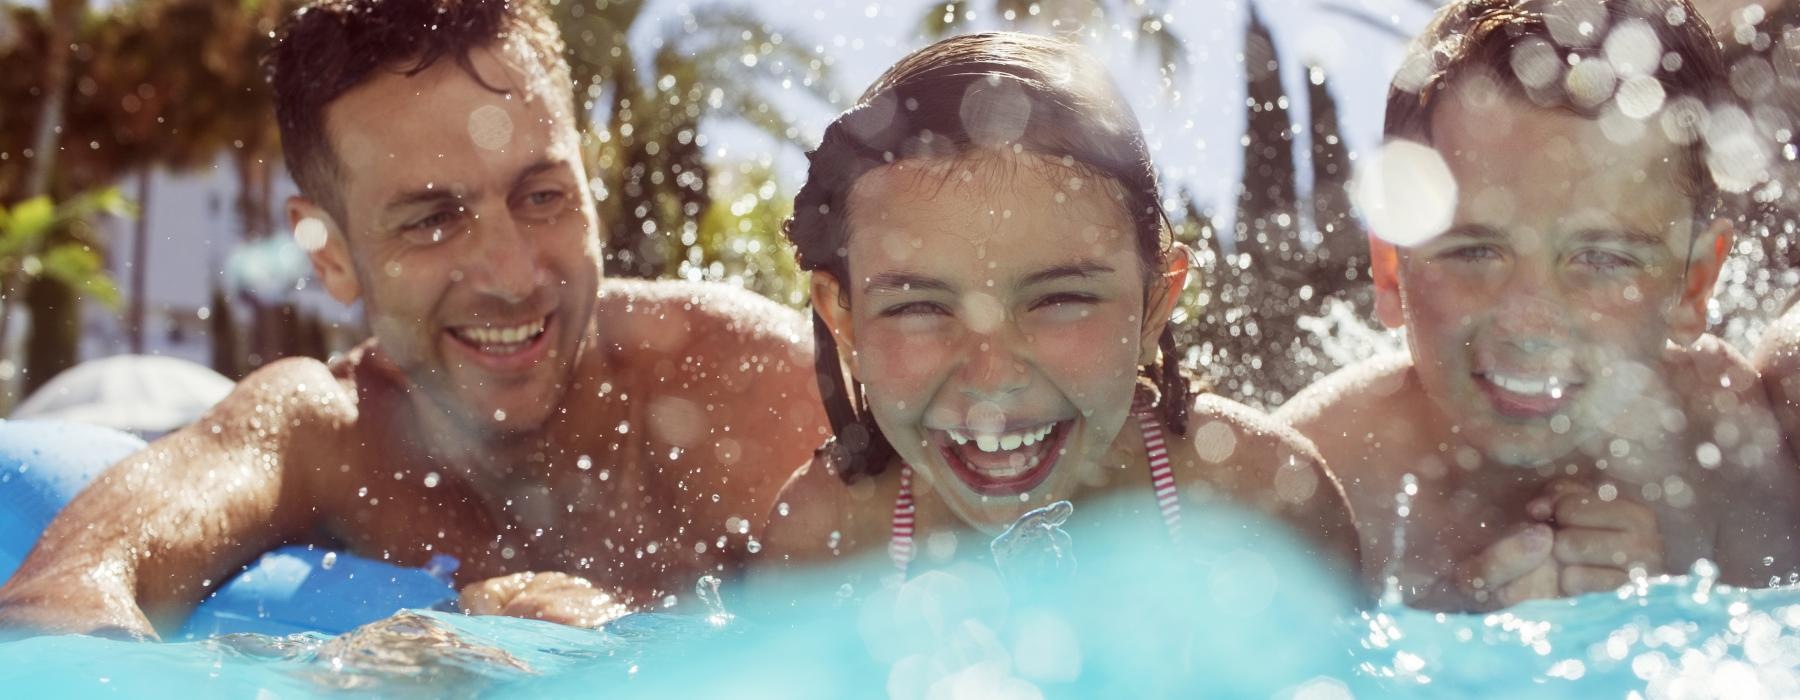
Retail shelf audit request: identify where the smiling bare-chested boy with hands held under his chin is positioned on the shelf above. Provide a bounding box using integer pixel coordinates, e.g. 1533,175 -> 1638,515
1282,0 -> 1800,610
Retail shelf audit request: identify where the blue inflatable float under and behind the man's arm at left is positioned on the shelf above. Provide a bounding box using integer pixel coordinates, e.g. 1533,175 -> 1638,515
0,421 -> 457,639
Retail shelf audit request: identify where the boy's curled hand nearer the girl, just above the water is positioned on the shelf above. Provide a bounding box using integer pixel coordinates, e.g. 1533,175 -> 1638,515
1411,524 -> 1561,612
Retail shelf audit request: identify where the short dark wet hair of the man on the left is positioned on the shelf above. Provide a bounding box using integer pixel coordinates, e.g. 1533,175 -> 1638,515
263,0 -> 574,225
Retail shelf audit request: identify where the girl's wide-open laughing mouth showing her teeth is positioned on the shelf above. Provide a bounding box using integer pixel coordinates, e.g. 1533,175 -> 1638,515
934,419 -> 1075,497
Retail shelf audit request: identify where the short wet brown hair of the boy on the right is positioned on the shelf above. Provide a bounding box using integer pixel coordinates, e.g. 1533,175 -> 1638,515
1382,0 -> 1748,225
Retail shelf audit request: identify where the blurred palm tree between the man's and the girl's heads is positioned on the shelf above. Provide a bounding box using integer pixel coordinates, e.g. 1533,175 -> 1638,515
553,0 -> 837,277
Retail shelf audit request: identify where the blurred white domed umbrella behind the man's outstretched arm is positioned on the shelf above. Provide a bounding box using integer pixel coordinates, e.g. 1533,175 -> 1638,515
13,354 -> 232,439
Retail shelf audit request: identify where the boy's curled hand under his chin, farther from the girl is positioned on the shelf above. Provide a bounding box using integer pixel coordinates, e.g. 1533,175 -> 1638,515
1525,479 -> 1663,596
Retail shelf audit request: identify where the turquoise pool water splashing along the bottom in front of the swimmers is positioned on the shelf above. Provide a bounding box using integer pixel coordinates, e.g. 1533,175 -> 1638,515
10,500 -> 1800,700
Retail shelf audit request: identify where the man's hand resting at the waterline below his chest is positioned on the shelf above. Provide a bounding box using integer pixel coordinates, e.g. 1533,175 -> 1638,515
459,572 -> 632,628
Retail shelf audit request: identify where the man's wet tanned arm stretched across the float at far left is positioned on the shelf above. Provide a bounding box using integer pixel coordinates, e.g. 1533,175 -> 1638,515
0,360 -> 355,637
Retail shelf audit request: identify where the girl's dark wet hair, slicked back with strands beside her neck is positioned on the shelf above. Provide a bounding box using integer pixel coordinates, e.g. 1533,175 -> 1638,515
785,32 -> 1190,482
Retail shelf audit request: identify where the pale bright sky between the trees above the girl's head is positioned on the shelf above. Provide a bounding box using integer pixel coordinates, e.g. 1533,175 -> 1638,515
634,0 -> 1429,221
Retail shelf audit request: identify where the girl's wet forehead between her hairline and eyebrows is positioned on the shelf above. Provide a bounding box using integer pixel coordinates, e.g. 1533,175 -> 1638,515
846,153 -> 1136,279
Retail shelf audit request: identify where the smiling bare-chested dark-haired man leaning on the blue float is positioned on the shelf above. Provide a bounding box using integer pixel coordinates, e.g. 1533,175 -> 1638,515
0,0 -> 824,635
